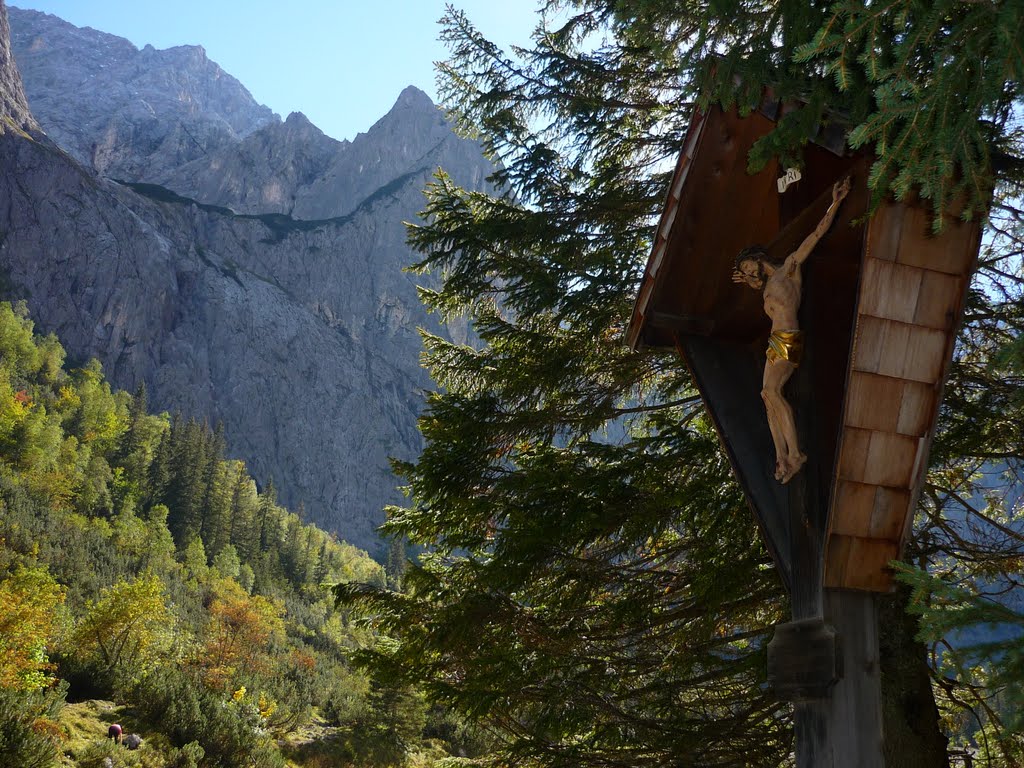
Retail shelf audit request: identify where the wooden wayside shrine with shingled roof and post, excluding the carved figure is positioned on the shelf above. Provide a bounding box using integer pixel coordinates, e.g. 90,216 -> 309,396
627,99 -> 980,768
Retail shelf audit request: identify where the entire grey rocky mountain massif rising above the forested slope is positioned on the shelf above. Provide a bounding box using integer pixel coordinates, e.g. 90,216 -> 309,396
0,0 -> 492,552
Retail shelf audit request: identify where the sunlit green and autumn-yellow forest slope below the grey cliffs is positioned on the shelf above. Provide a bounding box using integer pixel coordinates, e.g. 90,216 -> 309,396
0,303 -> 473,768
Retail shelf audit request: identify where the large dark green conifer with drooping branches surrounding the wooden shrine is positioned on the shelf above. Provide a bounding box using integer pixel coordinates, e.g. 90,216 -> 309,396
337,0 -> 1024,766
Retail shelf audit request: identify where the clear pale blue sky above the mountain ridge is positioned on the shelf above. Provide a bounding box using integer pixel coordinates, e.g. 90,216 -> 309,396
7,0 -> 539,139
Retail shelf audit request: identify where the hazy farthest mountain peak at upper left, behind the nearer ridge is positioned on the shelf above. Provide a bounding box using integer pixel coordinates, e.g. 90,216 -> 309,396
8,7 -> 280,176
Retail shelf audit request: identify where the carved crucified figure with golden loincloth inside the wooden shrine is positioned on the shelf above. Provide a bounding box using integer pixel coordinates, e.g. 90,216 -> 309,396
732,177 -> 850,483
